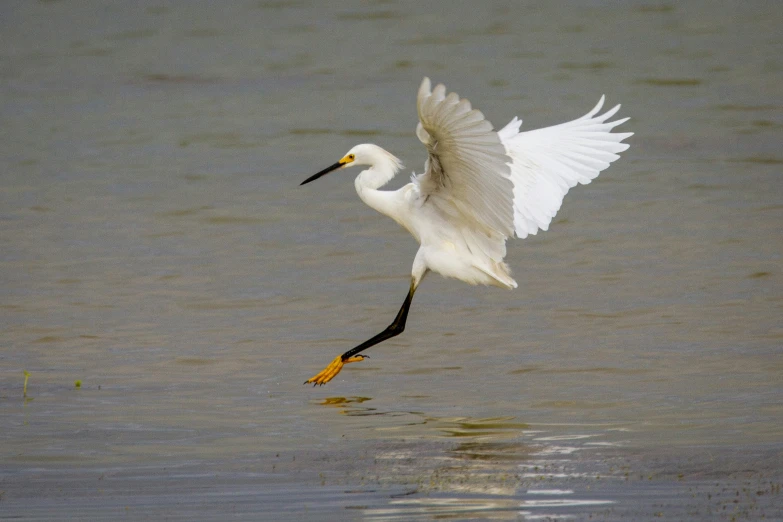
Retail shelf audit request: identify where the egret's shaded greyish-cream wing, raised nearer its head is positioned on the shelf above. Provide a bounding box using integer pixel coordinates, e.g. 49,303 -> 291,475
415,78 -> 514,240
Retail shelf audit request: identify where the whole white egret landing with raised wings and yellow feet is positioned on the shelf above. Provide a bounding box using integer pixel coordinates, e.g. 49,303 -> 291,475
302,78 -> 633,385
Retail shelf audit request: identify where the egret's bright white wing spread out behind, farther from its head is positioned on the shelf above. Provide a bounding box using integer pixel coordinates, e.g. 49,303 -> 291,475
498,96 -> 633,238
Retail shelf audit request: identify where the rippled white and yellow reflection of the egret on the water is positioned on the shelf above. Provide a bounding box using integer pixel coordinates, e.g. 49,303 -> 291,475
314,396 -> 610,520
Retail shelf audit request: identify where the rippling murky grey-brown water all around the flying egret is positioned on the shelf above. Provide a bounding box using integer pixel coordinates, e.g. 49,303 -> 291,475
0,1 -> 783,520
